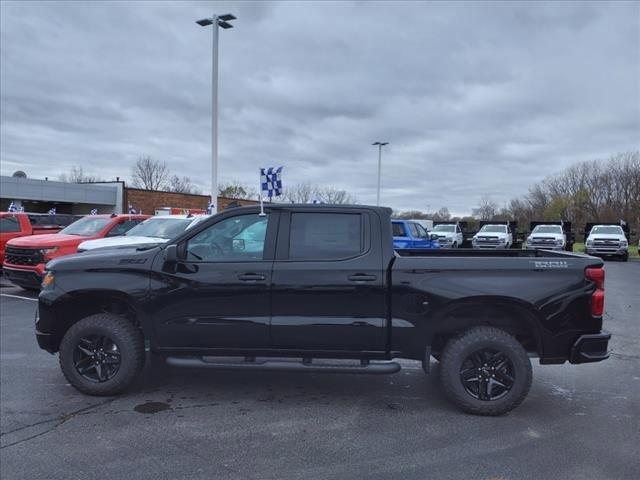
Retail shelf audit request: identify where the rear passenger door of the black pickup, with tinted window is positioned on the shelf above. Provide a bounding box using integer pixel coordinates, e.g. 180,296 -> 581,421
271,207 -> 390,351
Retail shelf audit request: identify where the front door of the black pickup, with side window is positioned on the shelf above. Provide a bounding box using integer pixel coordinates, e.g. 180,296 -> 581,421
149,212 -> 278,349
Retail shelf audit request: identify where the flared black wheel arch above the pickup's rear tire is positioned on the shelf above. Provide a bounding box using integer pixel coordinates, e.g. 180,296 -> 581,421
430,297 -> 543,357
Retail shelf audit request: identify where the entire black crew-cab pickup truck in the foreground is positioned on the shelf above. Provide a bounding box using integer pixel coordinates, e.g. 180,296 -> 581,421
36,205 -> 610,415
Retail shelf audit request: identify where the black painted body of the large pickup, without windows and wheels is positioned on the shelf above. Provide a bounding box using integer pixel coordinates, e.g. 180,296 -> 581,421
36,205 -> 606,363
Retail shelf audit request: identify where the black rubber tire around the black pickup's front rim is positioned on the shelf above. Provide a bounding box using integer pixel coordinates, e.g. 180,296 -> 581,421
60,313 -> 145,396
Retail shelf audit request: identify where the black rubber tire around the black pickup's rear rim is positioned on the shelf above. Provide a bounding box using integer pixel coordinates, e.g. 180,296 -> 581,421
440,327 -> 532,416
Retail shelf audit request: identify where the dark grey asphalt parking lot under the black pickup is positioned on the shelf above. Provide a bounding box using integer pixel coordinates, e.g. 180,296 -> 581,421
0,261 -> 640,480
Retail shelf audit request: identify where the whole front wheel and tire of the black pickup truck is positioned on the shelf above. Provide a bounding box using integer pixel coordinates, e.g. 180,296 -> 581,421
60,313 -> 145,396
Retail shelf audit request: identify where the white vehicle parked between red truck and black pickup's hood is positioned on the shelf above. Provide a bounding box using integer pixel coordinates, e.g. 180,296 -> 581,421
78,215 -> 210,252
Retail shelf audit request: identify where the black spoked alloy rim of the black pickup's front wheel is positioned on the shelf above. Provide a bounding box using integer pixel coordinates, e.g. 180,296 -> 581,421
73,334 -> 121,383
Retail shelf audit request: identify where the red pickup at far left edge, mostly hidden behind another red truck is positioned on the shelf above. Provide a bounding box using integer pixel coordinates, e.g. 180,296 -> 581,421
0,212 -> 81,268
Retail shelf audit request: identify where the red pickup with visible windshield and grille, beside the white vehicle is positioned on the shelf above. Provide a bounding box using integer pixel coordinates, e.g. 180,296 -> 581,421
2,215 -> 150,290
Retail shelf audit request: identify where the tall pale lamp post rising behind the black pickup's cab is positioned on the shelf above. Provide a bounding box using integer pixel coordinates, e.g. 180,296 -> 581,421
196,13 -> 236,213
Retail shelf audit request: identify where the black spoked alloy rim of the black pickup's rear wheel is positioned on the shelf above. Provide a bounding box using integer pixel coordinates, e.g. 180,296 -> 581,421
460,348 -> 515,401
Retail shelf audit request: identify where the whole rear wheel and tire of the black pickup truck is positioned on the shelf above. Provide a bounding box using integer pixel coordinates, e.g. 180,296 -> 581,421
440,327 -> 532,415
